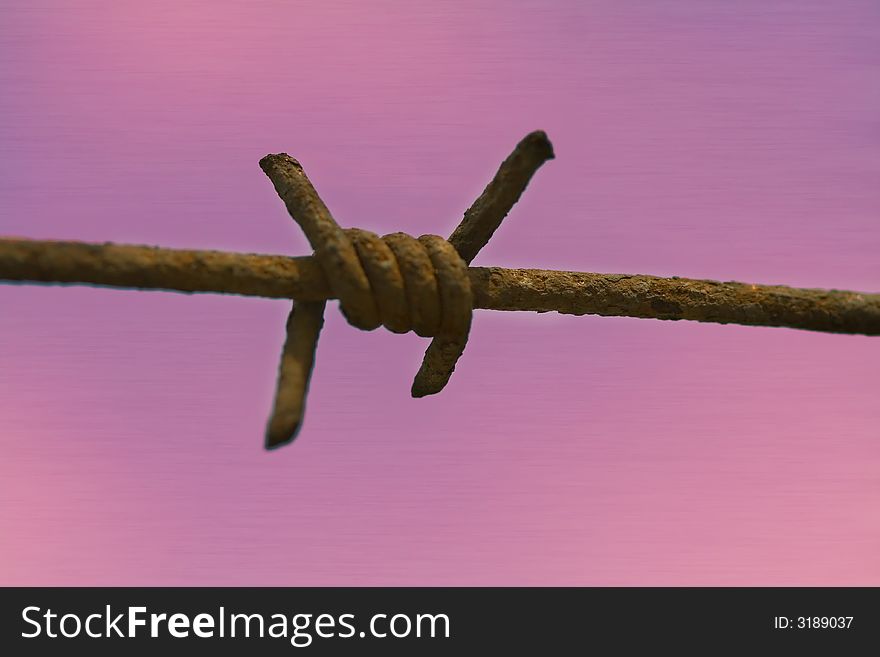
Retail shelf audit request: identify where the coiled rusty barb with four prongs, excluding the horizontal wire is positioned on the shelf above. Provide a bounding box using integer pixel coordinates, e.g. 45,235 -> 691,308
260,131 -> 553,448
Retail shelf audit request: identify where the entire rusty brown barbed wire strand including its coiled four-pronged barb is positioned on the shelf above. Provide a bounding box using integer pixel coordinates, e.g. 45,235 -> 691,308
0,131 -> 880,448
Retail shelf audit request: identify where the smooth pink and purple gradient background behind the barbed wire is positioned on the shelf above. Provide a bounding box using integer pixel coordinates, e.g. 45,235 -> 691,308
0,0 -> 880,585
